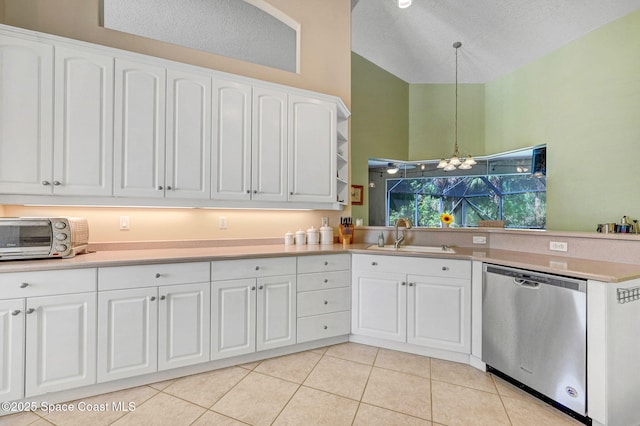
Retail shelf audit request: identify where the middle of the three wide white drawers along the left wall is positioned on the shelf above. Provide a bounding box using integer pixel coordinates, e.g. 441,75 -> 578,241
98,262 -> 209,290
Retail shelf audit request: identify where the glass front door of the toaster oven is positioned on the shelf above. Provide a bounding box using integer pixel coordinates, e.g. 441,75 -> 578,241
0,219 -> 53,259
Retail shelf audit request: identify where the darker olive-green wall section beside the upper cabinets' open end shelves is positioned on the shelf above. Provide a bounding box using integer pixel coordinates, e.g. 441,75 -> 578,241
350,53 -> 409,224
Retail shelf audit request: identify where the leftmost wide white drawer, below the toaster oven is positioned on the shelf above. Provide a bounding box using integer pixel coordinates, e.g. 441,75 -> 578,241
0,268 -> 97,299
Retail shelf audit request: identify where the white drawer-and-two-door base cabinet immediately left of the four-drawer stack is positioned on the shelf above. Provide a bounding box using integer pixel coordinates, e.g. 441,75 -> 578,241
211,257 -> 296,360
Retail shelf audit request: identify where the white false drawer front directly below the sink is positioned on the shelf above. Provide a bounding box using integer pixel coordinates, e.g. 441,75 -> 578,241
353,254 -> 471,279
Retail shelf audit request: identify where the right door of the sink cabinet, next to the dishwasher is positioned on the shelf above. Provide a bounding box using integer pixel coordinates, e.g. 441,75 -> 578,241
407,275 -> 471,353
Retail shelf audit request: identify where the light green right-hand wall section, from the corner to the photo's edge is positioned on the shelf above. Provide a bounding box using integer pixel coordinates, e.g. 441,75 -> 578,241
485,11 -> 640,231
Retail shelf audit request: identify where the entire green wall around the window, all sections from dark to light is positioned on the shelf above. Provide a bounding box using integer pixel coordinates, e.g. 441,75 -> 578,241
351,11 -> 640,231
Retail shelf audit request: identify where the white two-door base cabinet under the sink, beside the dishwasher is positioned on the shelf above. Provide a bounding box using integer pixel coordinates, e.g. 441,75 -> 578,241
352,255 -> 471,353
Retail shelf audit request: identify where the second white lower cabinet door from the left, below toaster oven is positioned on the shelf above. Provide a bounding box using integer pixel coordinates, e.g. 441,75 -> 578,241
25,293 -> 96,398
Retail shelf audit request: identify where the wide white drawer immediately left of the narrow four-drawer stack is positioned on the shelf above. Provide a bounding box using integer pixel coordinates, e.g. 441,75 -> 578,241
211,257 -> 296,281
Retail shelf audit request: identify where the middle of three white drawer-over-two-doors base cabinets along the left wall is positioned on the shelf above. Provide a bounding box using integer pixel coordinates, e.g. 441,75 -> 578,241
98,262 -> 210,383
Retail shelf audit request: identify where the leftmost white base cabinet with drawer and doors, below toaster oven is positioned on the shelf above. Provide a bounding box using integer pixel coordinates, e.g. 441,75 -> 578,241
0,269 -> 96,401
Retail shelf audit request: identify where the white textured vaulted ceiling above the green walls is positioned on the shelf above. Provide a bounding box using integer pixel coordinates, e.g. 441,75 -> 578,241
351,0 -> 640,83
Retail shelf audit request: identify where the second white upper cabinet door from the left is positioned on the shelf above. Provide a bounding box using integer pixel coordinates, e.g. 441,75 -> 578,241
53,46 -> 113,196
